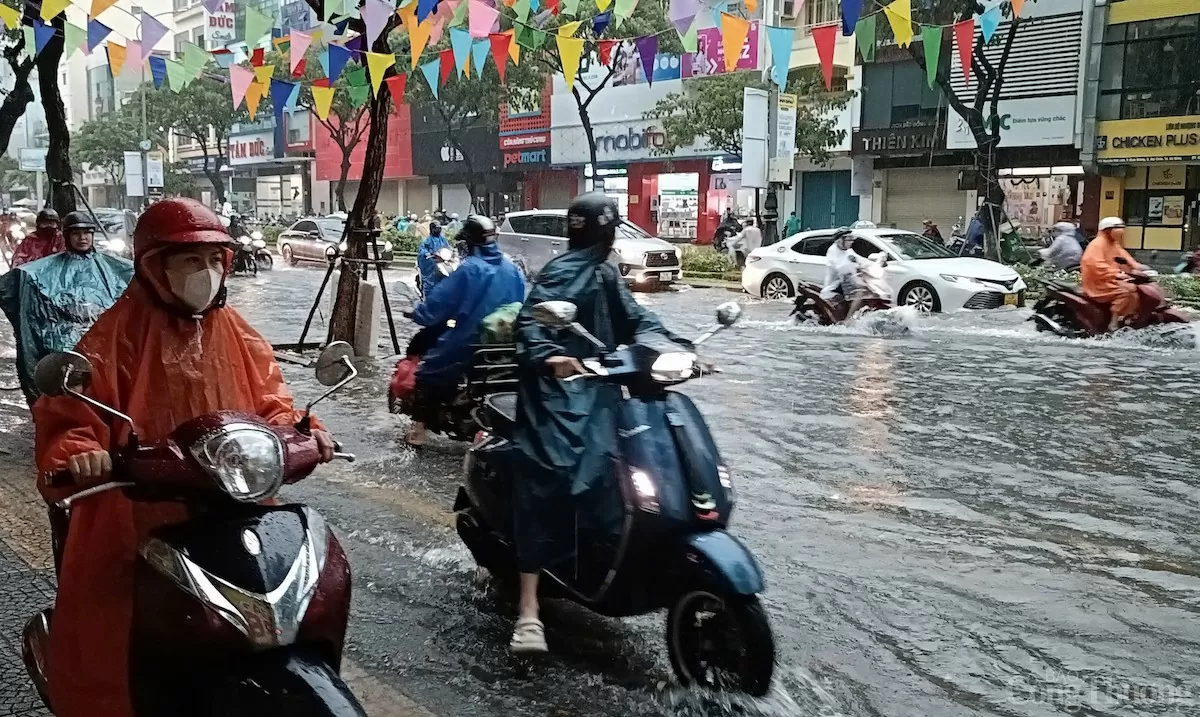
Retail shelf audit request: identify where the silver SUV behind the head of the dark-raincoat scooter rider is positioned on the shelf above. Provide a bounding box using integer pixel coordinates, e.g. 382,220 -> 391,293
499,209 -> 683,287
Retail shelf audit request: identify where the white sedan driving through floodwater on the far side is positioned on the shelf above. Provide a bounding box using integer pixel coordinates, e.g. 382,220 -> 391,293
742,227 -> 1025,312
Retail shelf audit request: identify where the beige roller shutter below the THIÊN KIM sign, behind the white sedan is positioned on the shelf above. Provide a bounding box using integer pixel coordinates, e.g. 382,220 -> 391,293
883,167 -> 966,236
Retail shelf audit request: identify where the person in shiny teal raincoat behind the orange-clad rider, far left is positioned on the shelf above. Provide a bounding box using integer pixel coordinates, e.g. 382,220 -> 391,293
0,212 -> 133,404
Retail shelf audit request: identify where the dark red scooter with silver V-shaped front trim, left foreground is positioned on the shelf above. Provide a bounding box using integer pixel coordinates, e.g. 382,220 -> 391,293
22,342 -> 366,717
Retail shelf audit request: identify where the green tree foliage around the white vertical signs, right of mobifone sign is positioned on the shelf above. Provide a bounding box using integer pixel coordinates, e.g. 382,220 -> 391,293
644,71 -> 851,164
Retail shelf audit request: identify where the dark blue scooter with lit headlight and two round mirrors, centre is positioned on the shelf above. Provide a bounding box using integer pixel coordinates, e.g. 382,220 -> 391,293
454,301 -> 775,695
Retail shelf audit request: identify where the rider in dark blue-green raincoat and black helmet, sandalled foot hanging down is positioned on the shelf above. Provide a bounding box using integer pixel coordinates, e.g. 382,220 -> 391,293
510,192 -> 692,653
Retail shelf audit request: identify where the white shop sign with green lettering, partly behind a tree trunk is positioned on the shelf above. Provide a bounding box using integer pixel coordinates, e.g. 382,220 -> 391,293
946,95 -> 1075,150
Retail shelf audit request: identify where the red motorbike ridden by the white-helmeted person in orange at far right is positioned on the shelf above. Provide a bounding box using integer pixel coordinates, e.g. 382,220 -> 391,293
1028,258 -> 1189,338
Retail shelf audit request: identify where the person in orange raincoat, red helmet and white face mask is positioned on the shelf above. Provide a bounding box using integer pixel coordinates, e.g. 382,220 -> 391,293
34,199 -> 332,717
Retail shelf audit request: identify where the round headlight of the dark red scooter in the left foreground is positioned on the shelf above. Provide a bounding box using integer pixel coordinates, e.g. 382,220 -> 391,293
192,423 -> 283,502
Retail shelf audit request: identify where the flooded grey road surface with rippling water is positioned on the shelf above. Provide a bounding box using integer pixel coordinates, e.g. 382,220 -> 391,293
0,264 -> 1200,717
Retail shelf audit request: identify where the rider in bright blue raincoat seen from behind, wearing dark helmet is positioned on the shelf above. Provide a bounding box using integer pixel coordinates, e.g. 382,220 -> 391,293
408,216 -> 524,446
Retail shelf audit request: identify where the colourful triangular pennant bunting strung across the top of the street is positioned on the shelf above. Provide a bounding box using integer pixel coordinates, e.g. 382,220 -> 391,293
21,0 -> 1025,121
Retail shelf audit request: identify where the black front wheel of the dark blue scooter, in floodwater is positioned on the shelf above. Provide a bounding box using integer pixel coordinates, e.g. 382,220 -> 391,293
667,590 -> 775,697
